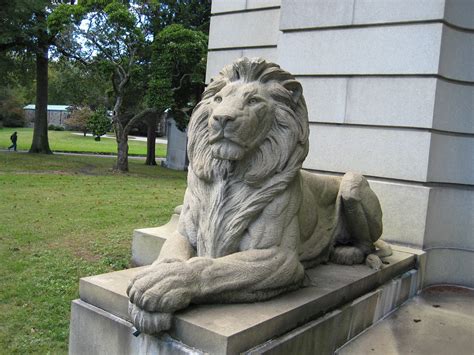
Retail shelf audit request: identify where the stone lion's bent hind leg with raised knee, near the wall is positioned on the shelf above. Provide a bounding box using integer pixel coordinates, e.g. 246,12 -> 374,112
331,173 -> 382,269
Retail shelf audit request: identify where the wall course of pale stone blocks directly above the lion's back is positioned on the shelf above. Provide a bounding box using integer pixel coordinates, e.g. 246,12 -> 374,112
303,123 -> 474,185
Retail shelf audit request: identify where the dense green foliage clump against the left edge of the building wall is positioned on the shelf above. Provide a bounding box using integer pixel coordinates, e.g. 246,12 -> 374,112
148,25 -> 208,130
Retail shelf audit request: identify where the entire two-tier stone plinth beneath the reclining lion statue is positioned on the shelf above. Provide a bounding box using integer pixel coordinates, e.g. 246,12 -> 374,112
69,249 -> 424,354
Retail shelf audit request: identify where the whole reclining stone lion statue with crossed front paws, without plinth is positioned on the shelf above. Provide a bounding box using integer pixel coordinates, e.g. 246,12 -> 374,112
127,58 -> 390,334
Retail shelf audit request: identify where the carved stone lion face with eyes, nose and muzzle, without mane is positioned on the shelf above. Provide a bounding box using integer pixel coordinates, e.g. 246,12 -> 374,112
208,82 -> 274,160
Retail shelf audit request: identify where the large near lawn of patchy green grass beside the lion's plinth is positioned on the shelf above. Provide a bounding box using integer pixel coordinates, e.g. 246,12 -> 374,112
0,152 -> 186,354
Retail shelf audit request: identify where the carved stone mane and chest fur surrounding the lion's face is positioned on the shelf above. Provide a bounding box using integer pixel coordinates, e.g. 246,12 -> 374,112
185,58 -> 309,257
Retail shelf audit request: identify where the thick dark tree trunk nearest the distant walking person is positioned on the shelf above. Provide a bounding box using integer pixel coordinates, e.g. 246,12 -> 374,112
29,21 -> 52,154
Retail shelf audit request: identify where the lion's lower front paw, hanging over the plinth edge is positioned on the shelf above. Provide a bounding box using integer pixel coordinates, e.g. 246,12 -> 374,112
128,302 -> 173,334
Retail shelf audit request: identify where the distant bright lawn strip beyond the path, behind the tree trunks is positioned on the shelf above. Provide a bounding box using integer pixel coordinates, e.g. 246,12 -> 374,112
0,128 -> 166,157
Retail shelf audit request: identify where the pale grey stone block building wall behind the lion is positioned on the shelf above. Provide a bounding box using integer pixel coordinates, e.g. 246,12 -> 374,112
207,0 -> 474,287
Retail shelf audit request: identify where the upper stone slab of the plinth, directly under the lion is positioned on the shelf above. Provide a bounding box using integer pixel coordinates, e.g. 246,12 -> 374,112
80,249 -> 416,354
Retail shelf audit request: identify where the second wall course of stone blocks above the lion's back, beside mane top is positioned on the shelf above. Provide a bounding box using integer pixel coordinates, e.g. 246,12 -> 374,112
298,77 -> 474,133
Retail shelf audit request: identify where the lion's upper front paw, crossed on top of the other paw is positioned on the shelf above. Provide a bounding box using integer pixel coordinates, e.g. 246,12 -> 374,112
127,262 -> 199,313
